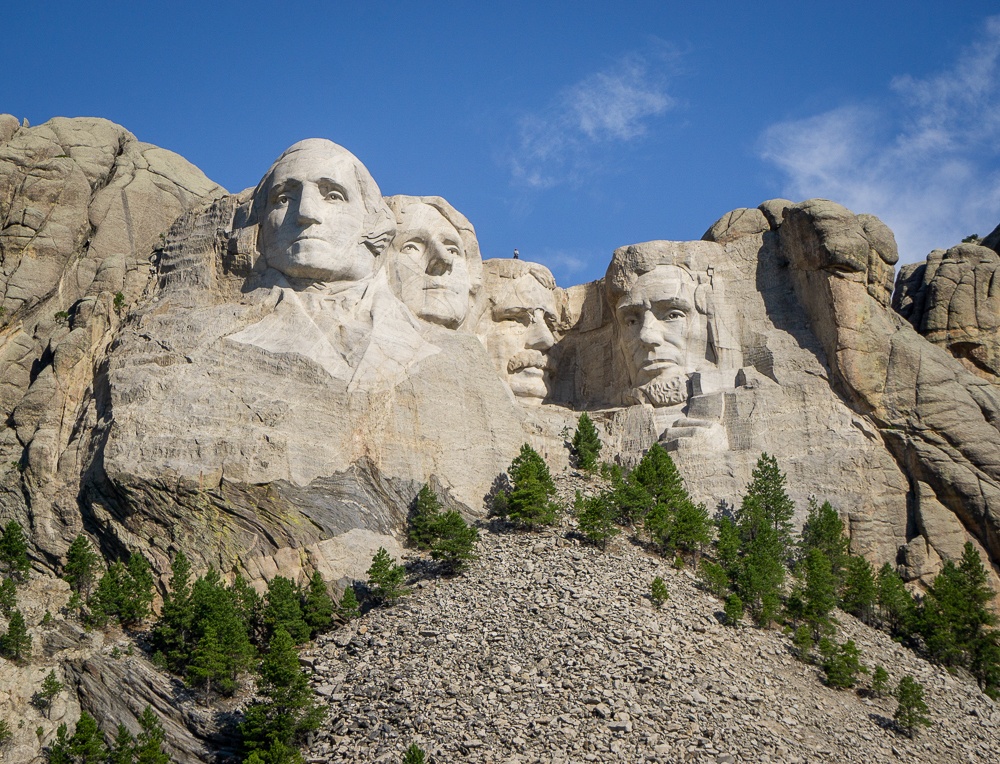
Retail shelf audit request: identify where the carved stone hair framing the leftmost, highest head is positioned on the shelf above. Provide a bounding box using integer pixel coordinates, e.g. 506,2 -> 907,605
234,138 -> 396,256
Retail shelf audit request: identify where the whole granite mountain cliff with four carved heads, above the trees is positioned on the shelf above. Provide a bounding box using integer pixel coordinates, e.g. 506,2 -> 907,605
0,116 -> 1000,596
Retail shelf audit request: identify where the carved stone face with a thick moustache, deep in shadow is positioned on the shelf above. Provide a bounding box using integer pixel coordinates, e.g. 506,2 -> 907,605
486,273 -> 558,403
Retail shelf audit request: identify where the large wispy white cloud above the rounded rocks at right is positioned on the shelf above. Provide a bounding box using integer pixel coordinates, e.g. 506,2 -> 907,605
760,16 -> 1000,262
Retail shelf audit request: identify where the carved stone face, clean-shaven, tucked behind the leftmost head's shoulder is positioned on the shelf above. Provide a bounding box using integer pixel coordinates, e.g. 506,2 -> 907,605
387,203 -> 472,329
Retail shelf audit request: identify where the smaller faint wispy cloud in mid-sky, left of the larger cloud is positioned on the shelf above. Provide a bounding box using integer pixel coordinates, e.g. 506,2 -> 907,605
509,46 -> 675,189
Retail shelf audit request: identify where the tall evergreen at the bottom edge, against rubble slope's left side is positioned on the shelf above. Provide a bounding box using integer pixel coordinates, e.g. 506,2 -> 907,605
240,627 -> 325,762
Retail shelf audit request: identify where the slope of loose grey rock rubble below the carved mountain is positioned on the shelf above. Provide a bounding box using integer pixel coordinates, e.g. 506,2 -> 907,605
303,496 -> 1000,763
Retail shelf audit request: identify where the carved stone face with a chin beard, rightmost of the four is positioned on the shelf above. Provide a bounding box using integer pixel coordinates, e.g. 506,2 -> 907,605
615,265 -> 702,406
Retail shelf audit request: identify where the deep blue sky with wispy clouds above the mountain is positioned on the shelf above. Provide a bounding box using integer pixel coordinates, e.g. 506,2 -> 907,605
7,0 -> 1000,286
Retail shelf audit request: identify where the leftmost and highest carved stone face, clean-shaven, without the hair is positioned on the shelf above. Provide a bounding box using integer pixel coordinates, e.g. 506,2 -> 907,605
259,145 -> 375,282
